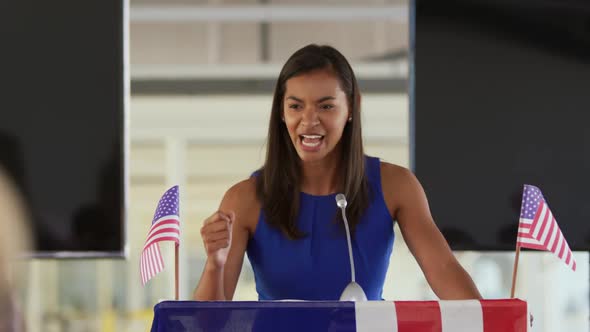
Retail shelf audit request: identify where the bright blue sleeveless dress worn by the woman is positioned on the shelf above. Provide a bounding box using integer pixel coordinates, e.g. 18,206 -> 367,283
247,157 -> 394,300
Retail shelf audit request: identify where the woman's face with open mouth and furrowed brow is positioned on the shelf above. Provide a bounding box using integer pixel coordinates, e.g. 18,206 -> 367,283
283,70 -> 350,162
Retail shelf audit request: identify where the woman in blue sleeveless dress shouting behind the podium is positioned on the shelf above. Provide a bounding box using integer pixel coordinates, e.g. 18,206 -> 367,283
194,45 -> 481,300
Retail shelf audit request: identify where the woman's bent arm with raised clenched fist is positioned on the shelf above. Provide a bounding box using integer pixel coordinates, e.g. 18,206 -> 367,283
193,179 -> 258,301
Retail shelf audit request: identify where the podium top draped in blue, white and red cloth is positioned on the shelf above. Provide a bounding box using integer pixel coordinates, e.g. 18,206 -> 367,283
151,299 -> 532,332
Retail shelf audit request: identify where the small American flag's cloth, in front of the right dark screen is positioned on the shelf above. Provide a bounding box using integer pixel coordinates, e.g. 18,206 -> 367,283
516,184 -> 576,271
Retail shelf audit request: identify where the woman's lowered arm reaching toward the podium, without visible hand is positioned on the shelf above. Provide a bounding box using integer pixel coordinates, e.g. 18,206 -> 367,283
381,163 -> 481,300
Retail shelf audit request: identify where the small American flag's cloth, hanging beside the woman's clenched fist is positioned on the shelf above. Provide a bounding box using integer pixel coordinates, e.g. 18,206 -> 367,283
139,186 -> 180,286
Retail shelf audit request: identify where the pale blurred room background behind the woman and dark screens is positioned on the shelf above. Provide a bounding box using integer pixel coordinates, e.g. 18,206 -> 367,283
2,0 -> 589,332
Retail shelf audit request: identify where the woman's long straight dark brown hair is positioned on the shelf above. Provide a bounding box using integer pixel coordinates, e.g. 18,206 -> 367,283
256,44 -> 369,239
